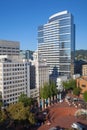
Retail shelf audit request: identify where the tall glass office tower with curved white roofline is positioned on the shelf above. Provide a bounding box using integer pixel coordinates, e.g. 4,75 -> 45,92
38,11 -> 75,78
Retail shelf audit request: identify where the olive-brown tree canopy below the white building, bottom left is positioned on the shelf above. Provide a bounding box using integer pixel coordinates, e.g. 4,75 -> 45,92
7,102 -> 35,124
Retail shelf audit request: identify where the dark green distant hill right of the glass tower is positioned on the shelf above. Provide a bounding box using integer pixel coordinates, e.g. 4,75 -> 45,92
75,49 -> 87,60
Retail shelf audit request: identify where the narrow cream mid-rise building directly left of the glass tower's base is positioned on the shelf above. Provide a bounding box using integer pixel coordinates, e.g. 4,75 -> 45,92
34,51 -> 49,88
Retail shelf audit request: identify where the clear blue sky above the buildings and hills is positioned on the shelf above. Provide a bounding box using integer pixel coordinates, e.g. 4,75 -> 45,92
0,0 -> 87,51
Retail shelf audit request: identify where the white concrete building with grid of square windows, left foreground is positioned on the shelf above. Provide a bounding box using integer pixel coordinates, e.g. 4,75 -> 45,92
0,55 -> 30,106
